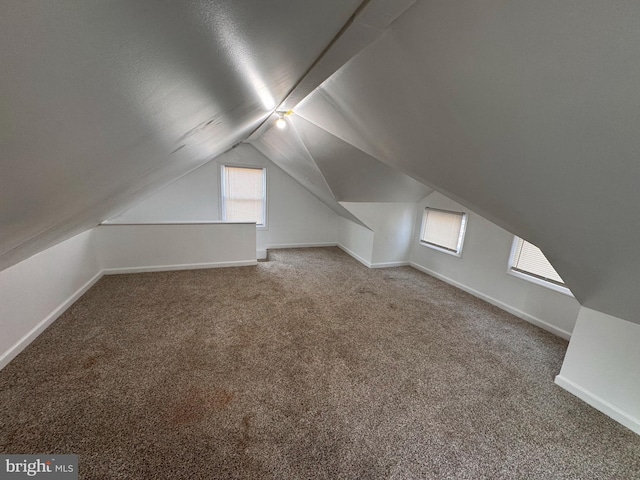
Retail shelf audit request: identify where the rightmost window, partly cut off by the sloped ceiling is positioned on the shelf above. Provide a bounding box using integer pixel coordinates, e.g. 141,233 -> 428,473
509,237 -> 571,295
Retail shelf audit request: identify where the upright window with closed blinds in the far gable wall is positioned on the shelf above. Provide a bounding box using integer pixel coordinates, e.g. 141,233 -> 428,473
222,165 -> 267,227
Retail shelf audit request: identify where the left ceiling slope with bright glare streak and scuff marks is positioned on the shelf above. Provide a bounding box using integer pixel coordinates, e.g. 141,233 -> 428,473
0,0 -> 360,268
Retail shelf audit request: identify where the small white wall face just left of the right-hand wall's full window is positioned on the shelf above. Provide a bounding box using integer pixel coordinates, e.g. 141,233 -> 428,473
340,202 -> 416,267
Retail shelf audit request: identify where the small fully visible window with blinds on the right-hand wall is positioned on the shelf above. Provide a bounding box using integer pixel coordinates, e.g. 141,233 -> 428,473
420,207 -> 467,256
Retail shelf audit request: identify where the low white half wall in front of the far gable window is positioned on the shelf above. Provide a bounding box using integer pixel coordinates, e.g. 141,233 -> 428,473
97,223 -> 256,273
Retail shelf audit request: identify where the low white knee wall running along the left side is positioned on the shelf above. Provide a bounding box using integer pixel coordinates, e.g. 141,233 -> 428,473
0,229 -> 101,368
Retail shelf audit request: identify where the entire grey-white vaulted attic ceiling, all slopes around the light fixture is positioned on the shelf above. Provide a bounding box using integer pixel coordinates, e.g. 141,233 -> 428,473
0,0 -> 640,323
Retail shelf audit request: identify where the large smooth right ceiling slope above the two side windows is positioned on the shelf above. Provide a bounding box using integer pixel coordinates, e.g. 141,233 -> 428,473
284,0 -> 640,323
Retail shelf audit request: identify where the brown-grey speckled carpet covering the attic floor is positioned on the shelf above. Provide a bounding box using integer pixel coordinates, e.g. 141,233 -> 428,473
0,248 -> 640,479
